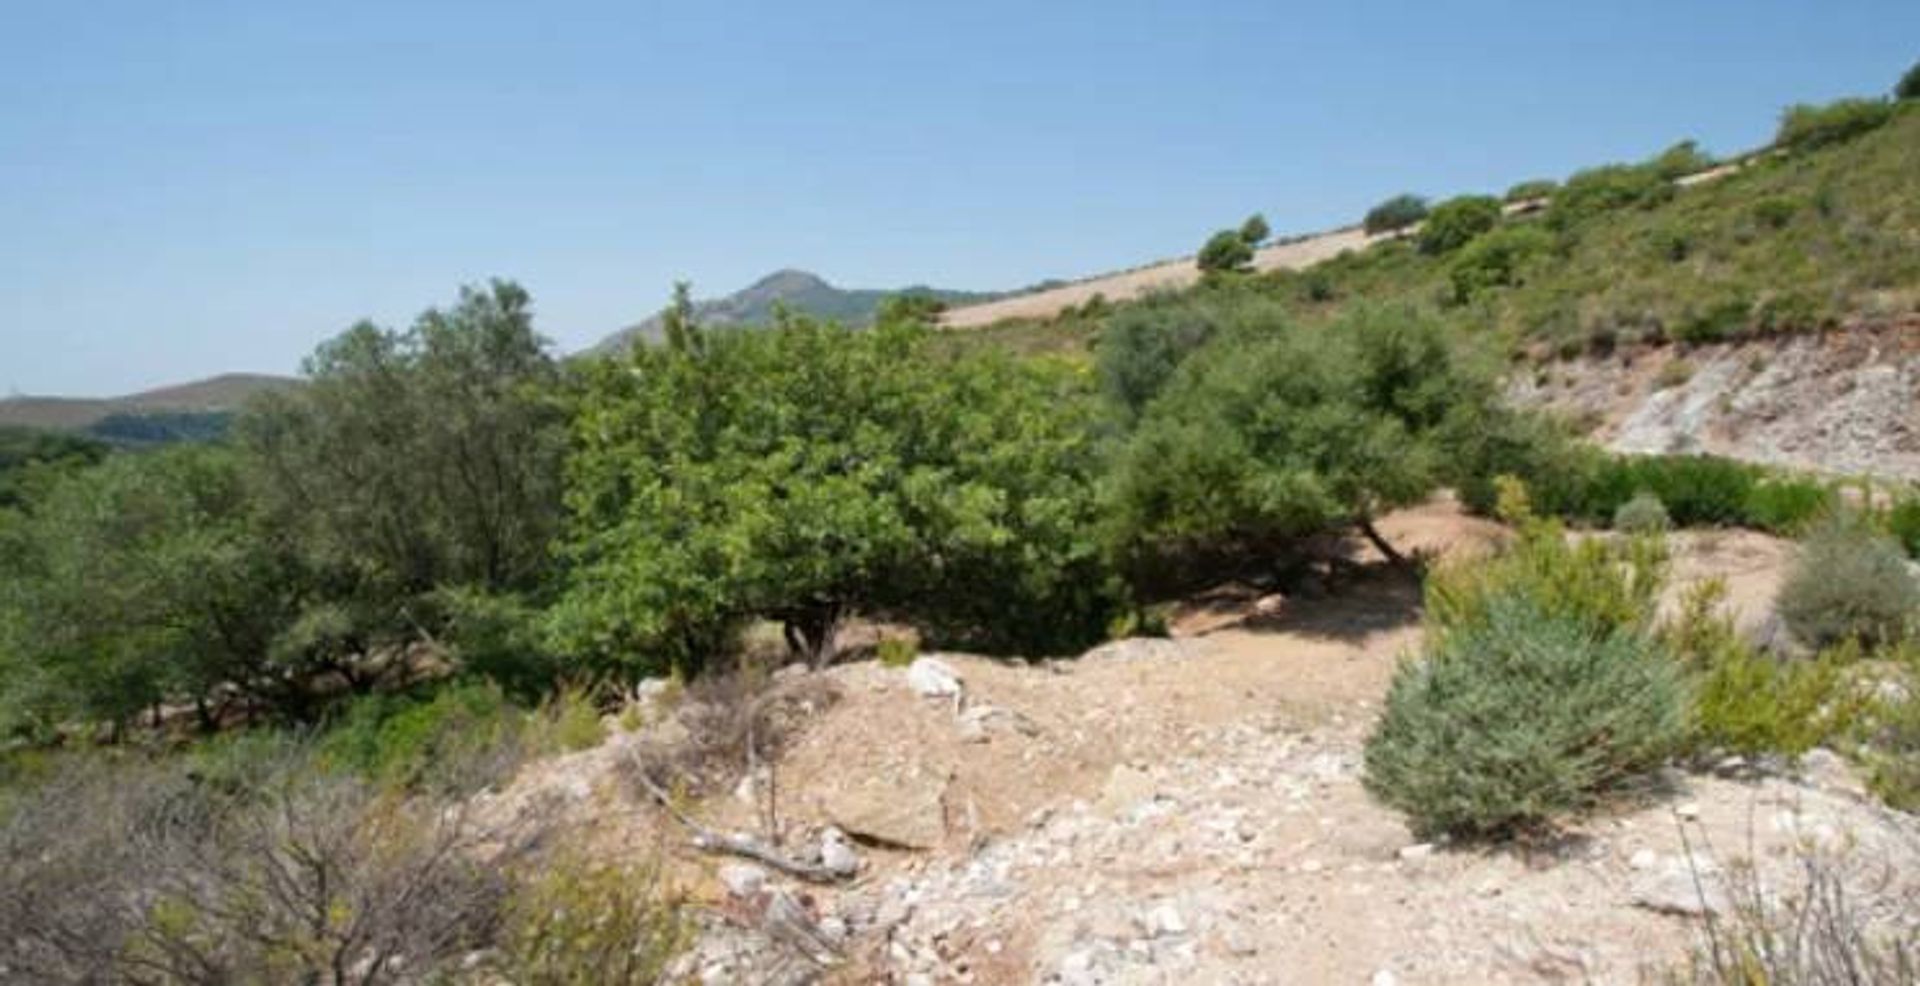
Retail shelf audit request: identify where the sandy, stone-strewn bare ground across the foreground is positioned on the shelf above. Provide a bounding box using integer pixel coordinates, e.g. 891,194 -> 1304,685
476,503 -> 1920,984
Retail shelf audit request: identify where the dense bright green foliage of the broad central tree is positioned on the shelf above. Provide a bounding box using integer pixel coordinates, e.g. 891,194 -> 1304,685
555,308 -> 1110,675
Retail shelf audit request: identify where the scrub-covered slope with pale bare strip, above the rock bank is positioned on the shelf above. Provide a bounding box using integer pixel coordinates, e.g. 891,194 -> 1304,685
943,107 -> 1920,355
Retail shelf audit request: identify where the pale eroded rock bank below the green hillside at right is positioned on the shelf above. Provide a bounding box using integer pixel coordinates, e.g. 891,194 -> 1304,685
1511,318 -> 1920,480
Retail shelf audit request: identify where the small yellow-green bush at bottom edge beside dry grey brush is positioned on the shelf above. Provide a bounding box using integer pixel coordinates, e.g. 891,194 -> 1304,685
493,844 -> 691,986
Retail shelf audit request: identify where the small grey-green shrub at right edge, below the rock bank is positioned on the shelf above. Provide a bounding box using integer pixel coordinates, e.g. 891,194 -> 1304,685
1776,510 -> 1920,648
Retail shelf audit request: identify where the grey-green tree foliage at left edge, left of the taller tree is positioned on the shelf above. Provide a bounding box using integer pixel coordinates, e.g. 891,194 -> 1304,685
0,447 -> 311,735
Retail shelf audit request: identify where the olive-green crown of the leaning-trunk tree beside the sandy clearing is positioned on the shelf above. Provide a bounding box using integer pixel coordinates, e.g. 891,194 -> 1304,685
1112,311 -> 1494,560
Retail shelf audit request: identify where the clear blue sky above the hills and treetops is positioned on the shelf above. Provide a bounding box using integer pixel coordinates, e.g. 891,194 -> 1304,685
0,0 -> 1920,393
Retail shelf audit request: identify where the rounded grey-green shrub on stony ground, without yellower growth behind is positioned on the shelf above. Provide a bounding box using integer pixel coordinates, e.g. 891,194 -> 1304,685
1365,597 -> 1686,836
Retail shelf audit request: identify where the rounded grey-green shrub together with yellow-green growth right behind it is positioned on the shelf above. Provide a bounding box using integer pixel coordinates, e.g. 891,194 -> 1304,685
1365,502 -> 1686,836
